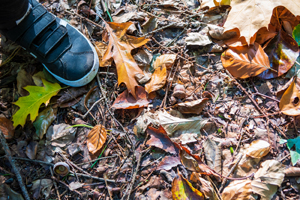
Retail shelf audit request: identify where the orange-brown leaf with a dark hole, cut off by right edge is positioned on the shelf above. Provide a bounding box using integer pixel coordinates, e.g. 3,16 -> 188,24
279,77 -> 300,116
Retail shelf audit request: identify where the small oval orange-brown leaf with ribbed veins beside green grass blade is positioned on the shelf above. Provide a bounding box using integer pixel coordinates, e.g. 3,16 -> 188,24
87,125 -> 107,154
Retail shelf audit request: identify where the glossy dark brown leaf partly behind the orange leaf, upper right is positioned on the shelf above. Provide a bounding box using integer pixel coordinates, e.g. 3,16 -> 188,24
258,30 -> 299,79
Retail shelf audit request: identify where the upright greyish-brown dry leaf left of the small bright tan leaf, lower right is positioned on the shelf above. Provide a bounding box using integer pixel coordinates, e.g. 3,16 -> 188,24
203,137 -> 222,174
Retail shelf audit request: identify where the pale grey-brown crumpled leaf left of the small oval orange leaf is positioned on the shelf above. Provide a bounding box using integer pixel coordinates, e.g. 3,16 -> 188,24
46,123 -> 77,147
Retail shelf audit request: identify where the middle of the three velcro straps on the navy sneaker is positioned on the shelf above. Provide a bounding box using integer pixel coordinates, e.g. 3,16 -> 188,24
21,13 -> 55,49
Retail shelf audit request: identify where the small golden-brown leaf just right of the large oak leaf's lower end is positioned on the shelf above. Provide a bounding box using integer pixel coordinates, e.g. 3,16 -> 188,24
145,66 -> 167,93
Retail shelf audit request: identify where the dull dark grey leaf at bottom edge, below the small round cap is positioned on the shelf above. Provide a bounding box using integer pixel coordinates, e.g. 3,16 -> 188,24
31,179 -> 53,199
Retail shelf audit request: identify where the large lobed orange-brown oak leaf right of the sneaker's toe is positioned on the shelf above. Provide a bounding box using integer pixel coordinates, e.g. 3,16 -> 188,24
103,22 -> 149,97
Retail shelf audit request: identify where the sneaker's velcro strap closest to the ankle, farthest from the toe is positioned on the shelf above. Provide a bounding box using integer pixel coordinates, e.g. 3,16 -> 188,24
6,5 -> 47,41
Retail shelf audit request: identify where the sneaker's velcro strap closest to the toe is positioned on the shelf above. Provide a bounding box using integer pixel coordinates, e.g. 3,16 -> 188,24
37,25 -> 67,58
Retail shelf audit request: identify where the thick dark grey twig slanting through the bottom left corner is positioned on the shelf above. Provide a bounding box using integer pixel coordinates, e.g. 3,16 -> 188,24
0,129 -> 30,200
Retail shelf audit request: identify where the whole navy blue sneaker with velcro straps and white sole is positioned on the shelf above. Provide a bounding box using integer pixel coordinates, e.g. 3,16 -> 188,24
0,0 -> 99,87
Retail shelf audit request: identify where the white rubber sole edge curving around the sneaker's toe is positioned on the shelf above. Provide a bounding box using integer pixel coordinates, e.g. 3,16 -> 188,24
43,19 -> 99,87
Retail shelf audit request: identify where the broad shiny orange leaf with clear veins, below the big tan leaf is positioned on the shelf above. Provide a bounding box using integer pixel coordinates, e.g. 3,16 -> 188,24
221,43 -> 270,79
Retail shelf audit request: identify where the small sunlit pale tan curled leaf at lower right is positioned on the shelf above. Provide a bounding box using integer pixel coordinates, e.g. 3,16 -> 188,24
246,140 -> 270,158
